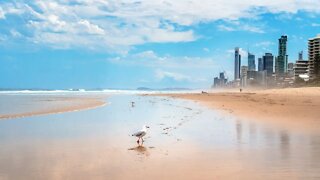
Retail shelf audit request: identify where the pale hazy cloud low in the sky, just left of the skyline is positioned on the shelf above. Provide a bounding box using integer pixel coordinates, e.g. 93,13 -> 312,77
108,51 -> 216,84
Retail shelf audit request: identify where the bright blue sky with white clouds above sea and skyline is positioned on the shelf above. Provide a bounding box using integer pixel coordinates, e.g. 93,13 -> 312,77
0,0 -> 320,89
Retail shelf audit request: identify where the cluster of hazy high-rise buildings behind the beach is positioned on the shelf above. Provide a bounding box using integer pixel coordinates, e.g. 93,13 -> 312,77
218,34 -> 320,88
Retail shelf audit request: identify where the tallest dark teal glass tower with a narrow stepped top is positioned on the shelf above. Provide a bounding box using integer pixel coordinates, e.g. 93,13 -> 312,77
275,36 -> 288,76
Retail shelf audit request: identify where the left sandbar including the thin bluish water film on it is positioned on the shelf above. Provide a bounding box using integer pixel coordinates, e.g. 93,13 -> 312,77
0,95 -> 106,120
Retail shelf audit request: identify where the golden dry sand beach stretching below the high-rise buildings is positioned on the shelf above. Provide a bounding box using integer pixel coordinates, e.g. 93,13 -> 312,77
159,87 -> 320,132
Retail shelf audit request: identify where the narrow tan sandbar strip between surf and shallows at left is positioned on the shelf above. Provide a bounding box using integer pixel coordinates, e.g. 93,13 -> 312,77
0,97 -> 107,120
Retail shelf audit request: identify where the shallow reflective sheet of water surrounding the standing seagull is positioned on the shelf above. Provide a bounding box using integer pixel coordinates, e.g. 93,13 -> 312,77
0,95 -> 320,179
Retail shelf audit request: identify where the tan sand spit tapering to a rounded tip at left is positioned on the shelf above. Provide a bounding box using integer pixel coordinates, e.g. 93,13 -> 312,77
0,97 -> 106,119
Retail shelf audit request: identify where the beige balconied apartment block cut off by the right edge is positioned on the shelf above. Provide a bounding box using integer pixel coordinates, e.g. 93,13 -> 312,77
308,34 -> 320,79
